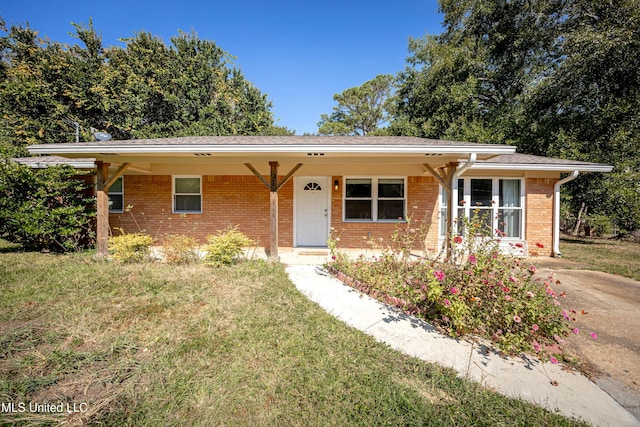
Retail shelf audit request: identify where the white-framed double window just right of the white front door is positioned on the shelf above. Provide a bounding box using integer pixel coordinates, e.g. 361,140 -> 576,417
343,178 -> 406,221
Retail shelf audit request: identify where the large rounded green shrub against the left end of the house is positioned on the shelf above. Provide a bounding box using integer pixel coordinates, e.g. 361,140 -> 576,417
0,160 -> 95,252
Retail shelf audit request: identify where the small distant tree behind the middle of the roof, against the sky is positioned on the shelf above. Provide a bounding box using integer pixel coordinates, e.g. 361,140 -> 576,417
318,74 -> 394,136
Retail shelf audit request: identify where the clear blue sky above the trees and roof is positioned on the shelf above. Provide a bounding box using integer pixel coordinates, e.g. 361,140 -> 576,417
0,0 -> 442,135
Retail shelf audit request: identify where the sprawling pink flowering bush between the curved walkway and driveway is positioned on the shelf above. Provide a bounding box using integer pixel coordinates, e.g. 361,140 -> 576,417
330,212 -> 571,356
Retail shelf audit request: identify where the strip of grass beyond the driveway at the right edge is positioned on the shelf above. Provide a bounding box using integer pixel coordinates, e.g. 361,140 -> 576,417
560,237 -> 640,280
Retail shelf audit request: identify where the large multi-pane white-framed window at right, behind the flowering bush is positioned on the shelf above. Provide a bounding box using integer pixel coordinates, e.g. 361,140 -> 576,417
440,178 -> 524,239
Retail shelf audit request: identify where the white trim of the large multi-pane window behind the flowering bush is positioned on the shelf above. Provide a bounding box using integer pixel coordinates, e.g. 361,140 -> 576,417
438,176 -> 527,242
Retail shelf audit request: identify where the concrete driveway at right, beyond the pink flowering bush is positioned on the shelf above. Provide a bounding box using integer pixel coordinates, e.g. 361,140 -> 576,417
535,258 -> 640,419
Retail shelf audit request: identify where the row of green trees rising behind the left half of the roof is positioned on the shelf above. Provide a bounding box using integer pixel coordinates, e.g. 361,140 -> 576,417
0,21 -> 282,157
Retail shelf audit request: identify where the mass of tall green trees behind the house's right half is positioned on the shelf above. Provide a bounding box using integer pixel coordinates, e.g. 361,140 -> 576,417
389,0 -> 640,232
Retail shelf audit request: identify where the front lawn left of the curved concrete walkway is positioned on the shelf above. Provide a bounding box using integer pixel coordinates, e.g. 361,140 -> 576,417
0,247 -> 588,426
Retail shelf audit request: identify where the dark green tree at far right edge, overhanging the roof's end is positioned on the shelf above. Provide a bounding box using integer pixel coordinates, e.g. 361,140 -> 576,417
524,0 -> 640,231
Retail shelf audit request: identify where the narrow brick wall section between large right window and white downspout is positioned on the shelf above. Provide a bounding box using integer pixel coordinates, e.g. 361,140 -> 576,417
525,178 -> 556,255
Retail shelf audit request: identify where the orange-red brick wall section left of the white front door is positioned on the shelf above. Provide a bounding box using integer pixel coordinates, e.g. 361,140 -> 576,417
109,175 -> 293,246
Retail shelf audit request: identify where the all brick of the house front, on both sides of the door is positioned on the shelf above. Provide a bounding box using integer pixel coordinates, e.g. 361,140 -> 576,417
109,175 -> 555,255
